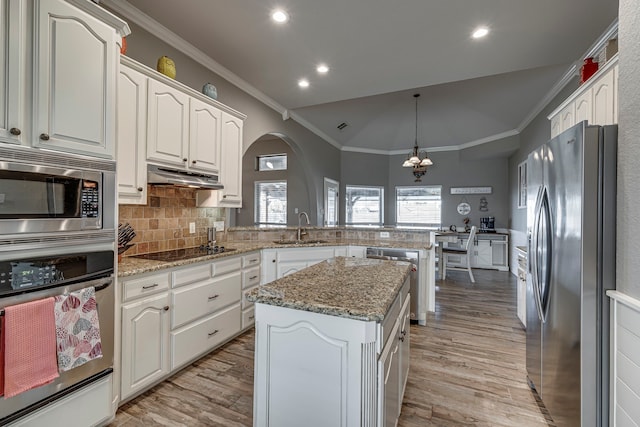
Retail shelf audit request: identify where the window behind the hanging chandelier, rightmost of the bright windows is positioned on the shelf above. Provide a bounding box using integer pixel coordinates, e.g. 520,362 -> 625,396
396,185 -> 442,228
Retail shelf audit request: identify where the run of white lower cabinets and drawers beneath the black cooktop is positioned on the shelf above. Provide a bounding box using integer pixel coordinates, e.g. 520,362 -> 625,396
120,251 -> 255,402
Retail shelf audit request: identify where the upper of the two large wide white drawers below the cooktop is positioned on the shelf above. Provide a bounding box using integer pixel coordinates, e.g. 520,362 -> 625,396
171,272 -> 240,328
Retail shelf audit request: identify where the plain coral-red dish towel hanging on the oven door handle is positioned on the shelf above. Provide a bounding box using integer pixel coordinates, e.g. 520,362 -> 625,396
3,297 -> 58,397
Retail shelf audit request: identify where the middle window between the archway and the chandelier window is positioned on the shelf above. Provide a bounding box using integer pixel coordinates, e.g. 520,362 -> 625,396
345,185 -> 384,227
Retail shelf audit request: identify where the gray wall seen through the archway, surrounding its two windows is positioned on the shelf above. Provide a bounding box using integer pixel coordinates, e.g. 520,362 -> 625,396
236,138 -> 312,226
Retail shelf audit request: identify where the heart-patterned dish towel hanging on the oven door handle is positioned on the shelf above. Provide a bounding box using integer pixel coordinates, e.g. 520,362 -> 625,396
54,287 -> 102,372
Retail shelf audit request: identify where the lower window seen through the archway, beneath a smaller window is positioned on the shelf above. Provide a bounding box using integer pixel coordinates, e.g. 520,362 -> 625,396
254,181 -> 287,227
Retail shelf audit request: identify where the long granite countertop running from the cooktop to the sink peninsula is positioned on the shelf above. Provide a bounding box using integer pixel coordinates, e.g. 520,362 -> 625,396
118,239 -> 432,277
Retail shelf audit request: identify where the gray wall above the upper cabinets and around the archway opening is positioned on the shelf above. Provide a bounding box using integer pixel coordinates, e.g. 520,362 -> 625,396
117,23 -> 340,224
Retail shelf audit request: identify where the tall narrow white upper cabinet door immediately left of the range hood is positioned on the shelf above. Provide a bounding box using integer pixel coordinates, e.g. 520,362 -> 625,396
116,66 -> 147,205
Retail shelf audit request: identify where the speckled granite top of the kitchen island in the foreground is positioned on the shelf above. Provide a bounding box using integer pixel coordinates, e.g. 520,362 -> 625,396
246,257 -> 411,322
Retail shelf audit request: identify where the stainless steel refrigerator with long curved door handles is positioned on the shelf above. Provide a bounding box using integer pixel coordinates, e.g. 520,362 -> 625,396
527,122 -> 617,426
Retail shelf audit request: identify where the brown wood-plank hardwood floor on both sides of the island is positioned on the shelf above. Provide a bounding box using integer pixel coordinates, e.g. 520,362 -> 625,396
110,270 -> 554,427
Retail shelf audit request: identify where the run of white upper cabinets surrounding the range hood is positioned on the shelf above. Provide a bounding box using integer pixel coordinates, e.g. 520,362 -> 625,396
118,56 -> 245,207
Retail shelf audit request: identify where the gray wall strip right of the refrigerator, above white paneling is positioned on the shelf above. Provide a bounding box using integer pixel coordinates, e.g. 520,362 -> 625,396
616,0 -> 640,299
